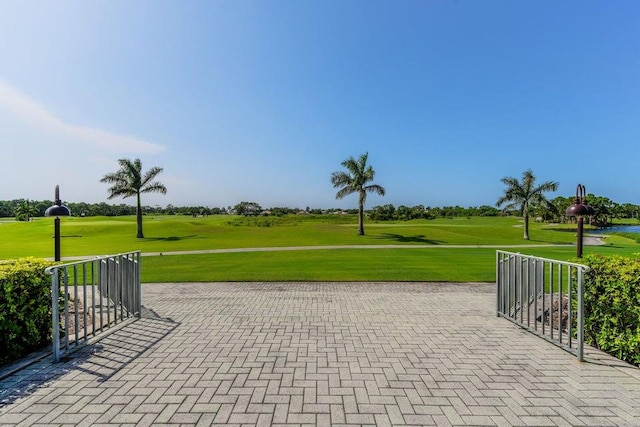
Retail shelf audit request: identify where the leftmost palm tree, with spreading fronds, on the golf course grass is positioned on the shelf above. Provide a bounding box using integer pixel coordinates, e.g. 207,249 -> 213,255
100,159 -> 167,239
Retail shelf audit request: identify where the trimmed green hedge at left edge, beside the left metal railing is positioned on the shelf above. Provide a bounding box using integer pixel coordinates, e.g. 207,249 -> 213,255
0,258 -> 53,365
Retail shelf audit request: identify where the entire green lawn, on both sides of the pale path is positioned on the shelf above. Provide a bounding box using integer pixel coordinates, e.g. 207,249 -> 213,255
0,215 -> 640,282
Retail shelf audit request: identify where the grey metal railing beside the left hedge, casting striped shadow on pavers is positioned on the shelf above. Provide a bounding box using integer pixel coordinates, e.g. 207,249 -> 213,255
45,251 -> 142,362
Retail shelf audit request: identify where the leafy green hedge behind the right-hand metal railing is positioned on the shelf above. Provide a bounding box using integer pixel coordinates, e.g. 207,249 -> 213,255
580,255 -> 640,366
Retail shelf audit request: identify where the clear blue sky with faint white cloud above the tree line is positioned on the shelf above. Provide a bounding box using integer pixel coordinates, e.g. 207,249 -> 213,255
0,0 -> 640,208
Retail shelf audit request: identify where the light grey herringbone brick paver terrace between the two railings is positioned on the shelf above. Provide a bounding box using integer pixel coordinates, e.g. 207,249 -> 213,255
0,283 -> 640,426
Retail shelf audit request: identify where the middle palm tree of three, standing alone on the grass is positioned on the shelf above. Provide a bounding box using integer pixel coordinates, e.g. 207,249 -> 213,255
331,153 -> 385,236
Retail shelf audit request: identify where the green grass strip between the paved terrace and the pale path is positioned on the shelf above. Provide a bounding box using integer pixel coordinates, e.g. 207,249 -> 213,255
142,249 -> 495,282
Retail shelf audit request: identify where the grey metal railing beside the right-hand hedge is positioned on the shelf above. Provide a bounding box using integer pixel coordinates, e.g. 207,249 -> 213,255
496,251 -> 589,361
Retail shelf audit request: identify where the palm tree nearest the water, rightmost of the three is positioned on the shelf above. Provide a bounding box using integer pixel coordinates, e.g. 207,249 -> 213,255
496,169 -> 558,240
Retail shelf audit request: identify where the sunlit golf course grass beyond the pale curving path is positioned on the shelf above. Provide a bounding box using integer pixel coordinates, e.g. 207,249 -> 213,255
0,215 -> 573,259
